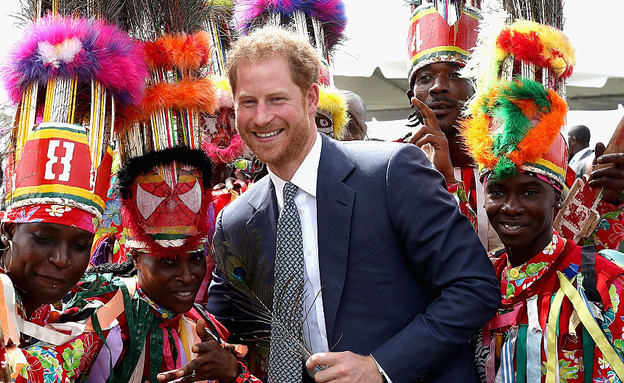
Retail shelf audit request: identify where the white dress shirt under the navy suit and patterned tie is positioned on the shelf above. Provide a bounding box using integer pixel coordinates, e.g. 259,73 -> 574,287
269,133 -> 329,354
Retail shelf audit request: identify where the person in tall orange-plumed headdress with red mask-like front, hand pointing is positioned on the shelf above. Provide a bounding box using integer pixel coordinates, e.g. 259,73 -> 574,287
85,0 -> 254,382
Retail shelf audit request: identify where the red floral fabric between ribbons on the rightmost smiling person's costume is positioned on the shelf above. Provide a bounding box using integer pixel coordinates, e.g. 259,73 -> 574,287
483,236 -> 624,383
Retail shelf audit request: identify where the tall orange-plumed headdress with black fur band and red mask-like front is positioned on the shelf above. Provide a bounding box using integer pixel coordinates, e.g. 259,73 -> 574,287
116,0 -> 218,256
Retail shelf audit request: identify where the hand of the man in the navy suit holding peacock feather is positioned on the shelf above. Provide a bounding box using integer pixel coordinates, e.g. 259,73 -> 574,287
306,351 -> 382,383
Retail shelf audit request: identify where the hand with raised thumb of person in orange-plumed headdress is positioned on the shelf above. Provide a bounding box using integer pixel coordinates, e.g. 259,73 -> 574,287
157,319 -> 238,383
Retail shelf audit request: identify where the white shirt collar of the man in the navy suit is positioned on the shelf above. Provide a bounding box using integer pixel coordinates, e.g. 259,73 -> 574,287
267,132 -> 323,208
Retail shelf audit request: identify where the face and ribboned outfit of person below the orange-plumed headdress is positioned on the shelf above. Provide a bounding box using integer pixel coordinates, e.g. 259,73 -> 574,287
84,250 -> 259,383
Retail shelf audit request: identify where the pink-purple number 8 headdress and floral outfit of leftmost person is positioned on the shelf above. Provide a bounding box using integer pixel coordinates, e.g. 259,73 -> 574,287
0,8 -> 147,382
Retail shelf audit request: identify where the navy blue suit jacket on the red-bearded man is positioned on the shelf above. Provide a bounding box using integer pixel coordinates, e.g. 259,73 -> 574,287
208,136 -> 500,383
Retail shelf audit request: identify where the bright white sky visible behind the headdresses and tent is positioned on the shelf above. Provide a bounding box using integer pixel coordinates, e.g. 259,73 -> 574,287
0,0 -> 624,141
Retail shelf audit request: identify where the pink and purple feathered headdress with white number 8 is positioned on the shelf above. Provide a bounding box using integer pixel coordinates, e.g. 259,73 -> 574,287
0,15 -> 148,232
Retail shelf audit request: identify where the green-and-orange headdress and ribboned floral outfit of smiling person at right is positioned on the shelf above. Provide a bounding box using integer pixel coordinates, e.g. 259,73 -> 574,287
462,79 -> 624,382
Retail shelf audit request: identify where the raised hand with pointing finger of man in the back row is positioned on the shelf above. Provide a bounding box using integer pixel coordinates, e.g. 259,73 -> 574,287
409,97 -> 455,184
